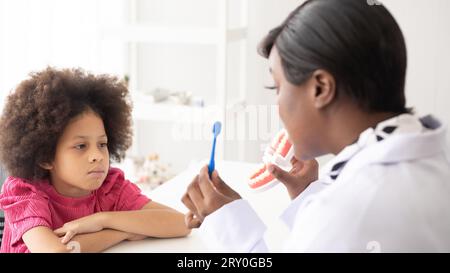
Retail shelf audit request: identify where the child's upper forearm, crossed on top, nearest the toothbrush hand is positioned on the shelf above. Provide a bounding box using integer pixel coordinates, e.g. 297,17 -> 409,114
102,209 -> 190,238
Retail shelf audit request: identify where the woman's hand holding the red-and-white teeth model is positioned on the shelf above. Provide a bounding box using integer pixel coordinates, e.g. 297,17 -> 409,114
268,157 -> 319,199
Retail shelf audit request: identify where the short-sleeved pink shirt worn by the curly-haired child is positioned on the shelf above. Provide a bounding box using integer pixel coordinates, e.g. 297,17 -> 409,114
0,168 -> 150,253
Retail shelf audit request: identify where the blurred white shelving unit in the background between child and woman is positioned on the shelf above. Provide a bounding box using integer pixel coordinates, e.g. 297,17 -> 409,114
100,0 -> 249,172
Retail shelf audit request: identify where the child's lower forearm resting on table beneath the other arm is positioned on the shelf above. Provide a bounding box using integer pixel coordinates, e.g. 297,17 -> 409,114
67,226 -> 130,253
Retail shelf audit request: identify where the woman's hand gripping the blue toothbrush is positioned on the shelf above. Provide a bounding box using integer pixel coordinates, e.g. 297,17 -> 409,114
181,166 -> 241,228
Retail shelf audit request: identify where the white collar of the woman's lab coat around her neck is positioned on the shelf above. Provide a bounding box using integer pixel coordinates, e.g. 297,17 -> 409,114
319,114 -> 446,184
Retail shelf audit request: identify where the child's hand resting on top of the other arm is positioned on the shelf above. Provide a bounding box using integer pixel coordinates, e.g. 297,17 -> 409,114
53,213 -> 104,244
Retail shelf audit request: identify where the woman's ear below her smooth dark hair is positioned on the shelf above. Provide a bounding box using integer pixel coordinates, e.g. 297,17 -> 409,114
313,70 -> 336,109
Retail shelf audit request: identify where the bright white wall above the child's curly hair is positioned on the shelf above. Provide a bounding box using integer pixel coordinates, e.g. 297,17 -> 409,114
0,0 -> 125,110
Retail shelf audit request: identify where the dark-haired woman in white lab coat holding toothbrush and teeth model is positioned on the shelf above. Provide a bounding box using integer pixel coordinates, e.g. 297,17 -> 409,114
182,0 -> 450,252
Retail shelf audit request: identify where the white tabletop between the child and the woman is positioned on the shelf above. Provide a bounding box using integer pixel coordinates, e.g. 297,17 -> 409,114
105,161 -> 290,252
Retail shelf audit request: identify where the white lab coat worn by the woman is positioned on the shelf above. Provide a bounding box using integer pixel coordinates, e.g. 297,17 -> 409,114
200,114 -> 450,252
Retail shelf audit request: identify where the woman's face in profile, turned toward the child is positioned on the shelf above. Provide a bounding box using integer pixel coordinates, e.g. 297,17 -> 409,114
269,46 -> 322,160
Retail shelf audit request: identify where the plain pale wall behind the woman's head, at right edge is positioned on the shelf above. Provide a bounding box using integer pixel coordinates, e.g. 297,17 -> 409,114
383,0 -> 450,141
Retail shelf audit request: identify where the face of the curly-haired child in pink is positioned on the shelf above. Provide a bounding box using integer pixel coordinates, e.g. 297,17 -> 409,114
44,110 -> 109,197
